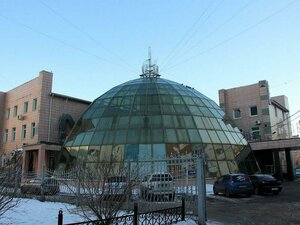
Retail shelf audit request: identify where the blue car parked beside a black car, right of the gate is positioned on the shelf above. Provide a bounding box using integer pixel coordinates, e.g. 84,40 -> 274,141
213,174 -> 253,197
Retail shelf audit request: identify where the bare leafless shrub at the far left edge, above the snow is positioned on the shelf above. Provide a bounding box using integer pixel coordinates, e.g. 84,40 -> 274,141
0,152 -> 22,218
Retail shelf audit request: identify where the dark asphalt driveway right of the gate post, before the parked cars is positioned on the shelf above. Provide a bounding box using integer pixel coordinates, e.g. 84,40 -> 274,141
206,179 -> 300,225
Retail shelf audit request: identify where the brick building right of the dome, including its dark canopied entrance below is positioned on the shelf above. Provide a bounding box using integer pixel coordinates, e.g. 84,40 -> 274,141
219,80 -> 300,178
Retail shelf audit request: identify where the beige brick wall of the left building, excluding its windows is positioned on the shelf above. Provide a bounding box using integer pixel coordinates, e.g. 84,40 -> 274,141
0,71 -> 89,160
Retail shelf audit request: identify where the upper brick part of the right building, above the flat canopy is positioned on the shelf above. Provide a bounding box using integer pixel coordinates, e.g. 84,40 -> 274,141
219,80 -> 292,141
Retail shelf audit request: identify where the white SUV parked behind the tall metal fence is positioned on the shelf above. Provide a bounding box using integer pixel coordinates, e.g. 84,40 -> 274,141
141,172 -> 175,201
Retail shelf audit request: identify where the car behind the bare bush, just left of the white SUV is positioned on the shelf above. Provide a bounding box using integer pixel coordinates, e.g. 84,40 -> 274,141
104,176 -> 129,200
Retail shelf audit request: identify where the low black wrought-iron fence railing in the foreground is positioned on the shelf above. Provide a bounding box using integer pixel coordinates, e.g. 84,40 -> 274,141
57,198 -> 185,225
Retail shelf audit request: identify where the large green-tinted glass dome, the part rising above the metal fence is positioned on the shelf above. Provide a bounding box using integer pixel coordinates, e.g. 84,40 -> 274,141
64,70 -> 257,177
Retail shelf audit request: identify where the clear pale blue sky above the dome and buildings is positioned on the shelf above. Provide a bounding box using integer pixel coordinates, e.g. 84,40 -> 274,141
0,0 -> 300,132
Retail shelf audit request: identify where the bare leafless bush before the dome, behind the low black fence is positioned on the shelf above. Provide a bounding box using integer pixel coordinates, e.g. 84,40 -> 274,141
62,151 -> 135,224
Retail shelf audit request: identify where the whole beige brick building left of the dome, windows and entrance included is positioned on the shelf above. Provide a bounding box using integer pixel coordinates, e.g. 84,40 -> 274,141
0,71 -> 90,175
